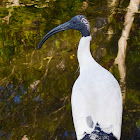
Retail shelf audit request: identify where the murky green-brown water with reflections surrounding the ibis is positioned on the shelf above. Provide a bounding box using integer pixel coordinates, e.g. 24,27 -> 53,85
0,0 -> 140,140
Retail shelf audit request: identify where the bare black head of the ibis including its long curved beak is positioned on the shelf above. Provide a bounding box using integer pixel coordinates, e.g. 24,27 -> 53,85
38,15 -> 90,49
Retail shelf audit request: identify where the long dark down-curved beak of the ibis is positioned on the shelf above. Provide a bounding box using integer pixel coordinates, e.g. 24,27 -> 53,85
38,22 -> 70,49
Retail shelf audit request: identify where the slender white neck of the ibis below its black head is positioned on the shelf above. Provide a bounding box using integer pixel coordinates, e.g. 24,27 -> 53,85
77,36 -> 95,69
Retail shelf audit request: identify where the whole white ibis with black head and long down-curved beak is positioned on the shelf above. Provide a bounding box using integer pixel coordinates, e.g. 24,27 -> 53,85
38,15 -> 122,140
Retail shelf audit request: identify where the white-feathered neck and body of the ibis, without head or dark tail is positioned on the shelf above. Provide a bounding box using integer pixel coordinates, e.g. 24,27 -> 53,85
71,36 -> 122,140
